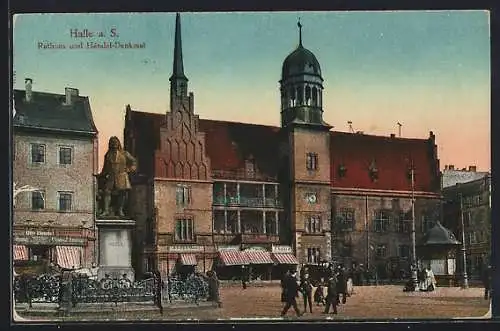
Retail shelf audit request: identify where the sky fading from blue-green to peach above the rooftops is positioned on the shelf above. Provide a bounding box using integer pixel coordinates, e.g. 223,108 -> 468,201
13,11 -> 491,171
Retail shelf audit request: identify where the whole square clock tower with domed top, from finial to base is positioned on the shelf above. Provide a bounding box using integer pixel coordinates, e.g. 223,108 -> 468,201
280,21 -> 332,270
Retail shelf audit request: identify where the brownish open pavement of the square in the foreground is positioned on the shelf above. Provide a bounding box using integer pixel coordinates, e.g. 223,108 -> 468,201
13,284 -> 490,321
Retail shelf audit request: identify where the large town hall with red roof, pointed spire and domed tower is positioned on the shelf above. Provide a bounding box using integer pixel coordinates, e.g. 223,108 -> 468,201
124,15 -> 440,278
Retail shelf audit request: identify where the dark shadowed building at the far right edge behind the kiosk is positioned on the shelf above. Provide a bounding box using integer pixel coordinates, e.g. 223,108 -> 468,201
443,170 -> 491,279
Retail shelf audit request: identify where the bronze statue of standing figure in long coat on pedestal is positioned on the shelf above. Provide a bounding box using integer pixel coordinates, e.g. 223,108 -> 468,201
98,136 -> 137,217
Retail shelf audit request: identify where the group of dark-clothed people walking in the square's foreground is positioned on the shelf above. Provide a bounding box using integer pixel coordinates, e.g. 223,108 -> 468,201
281,266 -> 348,316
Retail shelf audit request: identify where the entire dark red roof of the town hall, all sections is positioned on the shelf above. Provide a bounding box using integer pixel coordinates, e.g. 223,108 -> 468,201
124,111 -> 440,192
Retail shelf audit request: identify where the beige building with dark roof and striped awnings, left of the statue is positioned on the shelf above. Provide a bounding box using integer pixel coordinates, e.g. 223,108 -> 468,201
13,79 -> 97,268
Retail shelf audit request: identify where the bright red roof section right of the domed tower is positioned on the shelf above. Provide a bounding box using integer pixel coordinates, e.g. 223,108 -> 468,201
330,132 -> 439,192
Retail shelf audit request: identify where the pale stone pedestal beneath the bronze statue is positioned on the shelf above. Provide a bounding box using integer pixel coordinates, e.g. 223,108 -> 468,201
96,219 -> 135,281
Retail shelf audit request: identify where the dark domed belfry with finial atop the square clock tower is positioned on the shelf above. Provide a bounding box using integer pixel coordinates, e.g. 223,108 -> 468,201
280,21 -> 329,127
